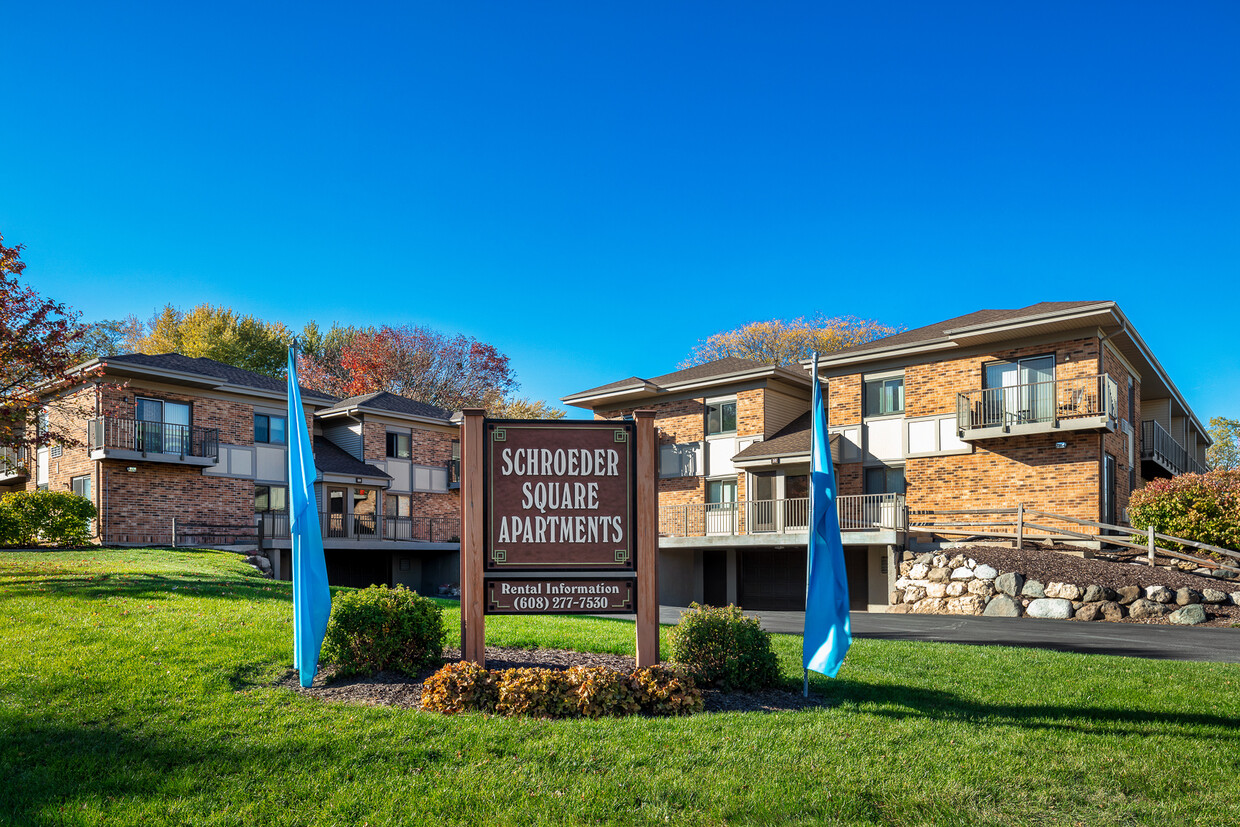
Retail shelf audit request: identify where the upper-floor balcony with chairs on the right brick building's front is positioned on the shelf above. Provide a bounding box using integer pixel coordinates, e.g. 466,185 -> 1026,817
956,373 -> 1120,440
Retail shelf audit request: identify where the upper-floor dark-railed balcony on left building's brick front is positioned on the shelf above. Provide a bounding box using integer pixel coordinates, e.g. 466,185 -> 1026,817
87,417 -> 219,467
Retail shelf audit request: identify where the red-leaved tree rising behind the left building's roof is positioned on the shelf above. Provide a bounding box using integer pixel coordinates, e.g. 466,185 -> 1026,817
298,325 -> 517,410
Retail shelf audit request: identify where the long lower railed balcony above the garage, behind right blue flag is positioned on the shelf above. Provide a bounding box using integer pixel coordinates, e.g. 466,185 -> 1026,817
658,493 -> 906,546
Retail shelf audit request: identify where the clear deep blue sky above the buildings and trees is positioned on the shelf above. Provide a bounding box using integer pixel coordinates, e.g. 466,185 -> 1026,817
0,0 -> 1240,420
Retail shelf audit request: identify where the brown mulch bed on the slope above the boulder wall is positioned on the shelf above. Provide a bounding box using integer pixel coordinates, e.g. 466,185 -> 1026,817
957,546 -> 1240,626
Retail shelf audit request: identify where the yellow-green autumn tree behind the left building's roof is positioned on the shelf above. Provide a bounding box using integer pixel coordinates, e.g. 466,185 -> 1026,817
136,304 -> 293,377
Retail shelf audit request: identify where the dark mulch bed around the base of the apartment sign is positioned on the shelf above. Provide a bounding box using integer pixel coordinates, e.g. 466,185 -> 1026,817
275,646 -> 827,712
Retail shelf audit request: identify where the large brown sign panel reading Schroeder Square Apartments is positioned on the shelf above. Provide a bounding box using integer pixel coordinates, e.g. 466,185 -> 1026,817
484,419 -> 637,573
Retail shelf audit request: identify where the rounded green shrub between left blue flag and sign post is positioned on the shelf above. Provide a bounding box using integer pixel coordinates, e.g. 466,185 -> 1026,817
322,585 -> 444,676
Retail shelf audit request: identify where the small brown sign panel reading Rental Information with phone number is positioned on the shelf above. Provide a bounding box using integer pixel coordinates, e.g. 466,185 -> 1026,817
486,578 -> 637,615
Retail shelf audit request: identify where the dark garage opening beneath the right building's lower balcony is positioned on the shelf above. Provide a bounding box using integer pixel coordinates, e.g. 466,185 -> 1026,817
737,548 -> 869,611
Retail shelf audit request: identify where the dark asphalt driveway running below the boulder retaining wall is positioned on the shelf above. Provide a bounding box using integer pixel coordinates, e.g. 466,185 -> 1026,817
660,606 -> 1240,663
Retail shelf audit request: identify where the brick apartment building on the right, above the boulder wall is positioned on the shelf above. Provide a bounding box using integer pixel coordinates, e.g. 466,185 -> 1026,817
563,301 -> 1210,609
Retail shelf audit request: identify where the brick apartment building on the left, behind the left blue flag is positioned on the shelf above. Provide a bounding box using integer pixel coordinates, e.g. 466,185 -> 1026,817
0,353 -> 460,591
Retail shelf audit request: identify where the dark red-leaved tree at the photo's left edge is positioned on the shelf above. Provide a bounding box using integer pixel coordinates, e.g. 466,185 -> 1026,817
0,234 -> 84,469
